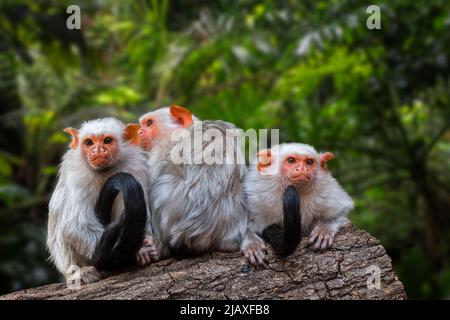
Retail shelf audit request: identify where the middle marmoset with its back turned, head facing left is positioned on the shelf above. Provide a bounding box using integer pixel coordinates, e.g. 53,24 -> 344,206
139,105 -> 251,260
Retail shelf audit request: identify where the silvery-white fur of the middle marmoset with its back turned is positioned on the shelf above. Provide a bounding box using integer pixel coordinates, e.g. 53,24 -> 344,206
140,108 -> 247,256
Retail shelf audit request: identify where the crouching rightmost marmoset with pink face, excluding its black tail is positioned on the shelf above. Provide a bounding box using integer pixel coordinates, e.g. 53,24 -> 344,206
244,143 -> 354,264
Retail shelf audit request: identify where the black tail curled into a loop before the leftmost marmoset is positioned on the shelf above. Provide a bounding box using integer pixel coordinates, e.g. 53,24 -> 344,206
92,172 -> 147,271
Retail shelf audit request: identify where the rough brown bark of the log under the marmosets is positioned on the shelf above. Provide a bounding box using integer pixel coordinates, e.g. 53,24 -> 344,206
0,225 -> 406,300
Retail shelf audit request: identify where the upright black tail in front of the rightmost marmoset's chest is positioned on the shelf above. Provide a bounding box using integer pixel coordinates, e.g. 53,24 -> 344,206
262,186 -> 302,257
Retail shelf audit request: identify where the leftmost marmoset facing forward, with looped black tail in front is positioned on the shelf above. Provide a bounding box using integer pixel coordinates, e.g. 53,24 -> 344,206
47,118 -> 153,283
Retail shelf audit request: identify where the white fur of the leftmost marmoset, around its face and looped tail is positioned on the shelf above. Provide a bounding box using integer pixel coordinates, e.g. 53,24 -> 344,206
47,118 -> 152,274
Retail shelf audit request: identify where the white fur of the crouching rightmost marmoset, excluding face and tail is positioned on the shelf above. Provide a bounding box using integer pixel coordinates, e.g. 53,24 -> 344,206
244,143 -> 354,238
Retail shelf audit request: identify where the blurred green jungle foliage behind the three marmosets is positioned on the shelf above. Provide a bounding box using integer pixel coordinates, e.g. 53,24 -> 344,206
0,0 -> 450,298
